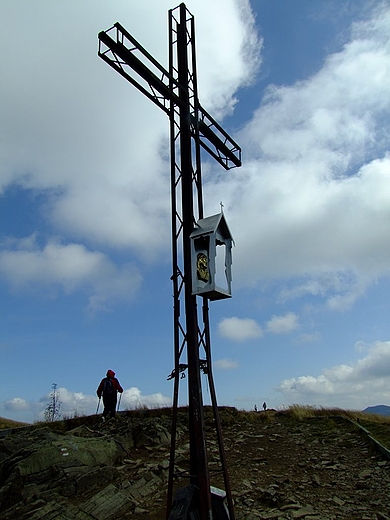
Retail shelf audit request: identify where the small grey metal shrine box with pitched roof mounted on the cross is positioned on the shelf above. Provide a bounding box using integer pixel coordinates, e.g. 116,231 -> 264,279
190,213 -> 233,300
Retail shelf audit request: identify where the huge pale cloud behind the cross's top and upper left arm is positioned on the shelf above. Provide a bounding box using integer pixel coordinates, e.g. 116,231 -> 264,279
0,0 -> 261,259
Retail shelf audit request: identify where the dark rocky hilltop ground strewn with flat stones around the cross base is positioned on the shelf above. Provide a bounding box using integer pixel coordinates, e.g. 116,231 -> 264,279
0,409 -> 390,520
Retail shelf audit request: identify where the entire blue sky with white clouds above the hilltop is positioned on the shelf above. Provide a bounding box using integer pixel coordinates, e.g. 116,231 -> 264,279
0,0 -> 390,421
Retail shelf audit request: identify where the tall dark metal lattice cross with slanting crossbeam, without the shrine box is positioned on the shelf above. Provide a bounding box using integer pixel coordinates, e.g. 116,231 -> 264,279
98,3 -> 241,520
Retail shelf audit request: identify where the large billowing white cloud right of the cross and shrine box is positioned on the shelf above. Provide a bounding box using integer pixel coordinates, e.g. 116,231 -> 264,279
201,3 -> 390,310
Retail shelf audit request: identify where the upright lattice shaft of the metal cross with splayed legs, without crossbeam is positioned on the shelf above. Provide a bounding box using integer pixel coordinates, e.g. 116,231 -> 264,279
167,4 -> 234,519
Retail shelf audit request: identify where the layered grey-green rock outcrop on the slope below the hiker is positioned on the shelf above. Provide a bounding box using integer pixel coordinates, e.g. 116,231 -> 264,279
0,418 -> 170,520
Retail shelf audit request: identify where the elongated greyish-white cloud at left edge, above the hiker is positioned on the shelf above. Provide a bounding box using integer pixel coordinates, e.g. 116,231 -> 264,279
0,237 -> 141,312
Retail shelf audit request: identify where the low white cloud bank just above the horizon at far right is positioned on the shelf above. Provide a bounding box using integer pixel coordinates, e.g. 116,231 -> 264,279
278,341 -> 390,410
